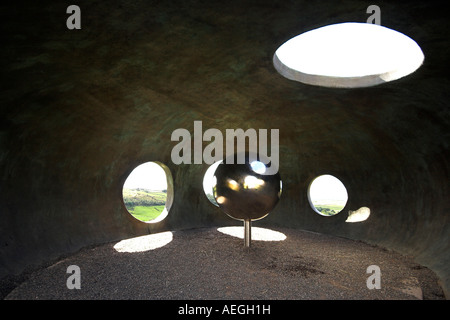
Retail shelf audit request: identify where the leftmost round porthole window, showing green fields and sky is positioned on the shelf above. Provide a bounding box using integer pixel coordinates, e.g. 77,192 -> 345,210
122,162 -> 173,223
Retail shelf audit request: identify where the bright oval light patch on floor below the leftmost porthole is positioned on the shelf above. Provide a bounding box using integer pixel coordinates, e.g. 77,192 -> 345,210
114,231 -> 173,252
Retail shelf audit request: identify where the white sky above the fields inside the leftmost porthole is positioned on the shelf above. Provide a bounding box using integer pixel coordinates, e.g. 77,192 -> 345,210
123,162 -> 167,190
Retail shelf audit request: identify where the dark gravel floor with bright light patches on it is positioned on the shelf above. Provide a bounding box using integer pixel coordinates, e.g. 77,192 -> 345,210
6,227 -> 444,300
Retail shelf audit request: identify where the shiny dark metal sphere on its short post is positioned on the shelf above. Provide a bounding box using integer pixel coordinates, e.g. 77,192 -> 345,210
213,153 -> 281,247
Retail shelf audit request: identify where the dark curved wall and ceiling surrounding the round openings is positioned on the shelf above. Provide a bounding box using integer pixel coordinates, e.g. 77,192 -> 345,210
0,1 -> 450,298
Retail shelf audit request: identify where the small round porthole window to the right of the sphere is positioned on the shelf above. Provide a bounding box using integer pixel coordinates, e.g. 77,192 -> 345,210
308,174 -> 348,216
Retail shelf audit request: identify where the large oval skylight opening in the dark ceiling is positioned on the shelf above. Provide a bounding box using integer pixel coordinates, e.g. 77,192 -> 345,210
273,22 -> 424,88
